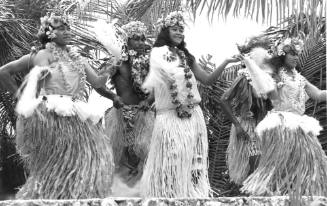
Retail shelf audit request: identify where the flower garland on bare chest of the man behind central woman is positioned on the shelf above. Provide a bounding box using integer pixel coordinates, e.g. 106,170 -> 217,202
128,50 -> 150,99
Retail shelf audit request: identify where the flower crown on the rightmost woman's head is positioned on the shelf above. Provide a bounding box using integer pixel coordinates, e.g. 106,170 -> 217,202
273,38 -> 304,56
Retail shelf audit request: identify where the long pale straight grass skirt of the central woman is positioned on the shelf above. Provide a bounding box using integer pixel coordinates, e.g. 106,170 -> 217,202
140,106 -> 210,198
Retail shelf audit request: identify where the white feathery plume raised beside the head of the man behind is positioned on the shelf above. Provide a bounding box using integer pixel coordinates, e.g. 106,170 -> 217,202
94,20 -> 127,61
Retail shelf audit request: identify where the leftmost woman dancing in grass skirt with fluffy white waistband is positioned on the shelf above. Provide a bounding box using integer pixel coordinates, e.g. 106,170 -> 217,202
0,14 -> 114,199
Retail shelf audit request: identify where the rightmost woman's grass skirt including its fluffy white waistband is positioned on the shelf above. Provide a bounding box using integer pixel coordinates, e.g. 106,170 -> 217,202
242,112 -> 327,196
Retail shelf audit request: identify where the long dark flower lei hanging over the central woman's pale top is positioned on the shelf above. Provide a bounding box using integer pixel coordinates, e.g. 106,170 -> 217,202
165,48 -> 194,119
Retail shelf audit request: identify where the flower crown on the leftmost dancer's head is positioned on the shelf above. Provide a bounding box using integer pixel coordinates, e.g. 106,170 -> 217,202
39,13 -> 69,39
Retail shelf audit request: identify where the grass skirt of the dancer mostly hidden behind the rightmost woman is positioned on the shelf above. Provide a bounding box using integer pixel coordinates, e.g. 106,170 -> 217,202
227,118 -> 261,184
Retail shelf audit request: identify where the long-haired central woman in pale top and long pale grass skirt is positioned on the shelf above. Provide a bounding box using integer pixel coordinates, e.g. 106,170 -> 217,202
141,12 -> 239,198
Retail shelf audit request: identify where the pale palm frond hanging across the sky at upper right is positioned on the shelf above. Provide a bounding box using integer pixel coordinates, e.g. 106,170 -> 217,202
186,0 -> 326,38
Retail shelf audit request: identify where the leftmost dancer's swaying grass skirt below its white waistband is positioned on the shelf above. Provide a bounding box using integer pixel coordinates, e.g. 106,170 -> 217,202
16,103 -> 114,199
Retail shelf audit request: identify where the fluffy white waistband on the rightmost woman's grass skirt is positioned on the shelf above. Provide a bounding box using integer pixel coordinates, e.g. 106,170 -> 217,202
256,111 -> 322,136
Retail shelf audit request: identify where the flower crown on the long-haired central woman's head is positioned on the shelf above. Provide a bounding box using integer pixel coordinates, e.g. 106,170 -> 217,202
155,11 -> 186,31
